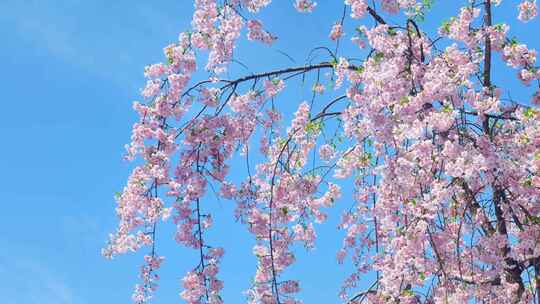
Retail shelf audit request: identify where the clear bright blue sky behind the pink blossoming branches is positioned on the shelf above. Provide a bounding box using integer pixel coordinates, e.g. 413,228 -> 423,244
0,0 -> 540,304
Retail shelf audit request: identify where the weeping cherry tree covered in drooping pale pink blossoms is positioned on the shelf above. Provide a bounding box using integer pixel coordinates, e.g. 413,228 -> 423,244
103,0 -> 540,304
